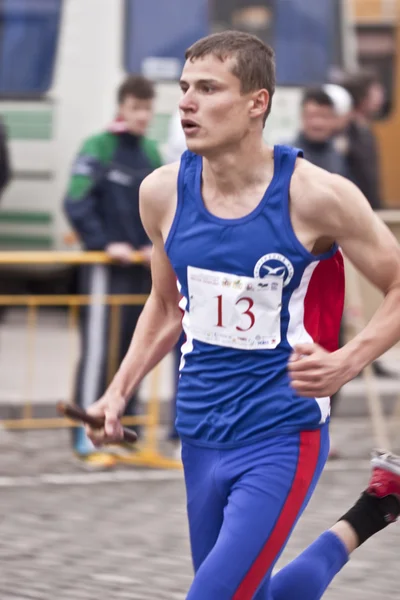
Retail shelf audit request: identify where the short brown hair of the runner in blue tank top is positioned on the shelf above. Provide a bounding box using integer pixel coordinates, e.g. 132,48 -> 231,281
185,30 -> 275,123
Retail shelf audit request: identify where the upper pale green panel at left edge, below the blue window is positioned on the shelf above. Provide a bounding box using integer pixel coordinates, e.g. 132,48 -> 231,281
1,109 -> 53,140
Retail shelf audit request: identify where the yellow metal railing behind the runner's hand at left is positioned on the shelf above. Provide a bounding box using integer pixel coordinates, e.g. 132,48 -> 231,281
0,251 -> 180,468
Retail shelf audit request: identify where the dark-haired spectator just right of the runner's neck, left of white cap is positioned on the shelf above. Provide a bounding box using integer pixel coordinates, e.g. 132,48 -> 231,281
293,88 -> 346,175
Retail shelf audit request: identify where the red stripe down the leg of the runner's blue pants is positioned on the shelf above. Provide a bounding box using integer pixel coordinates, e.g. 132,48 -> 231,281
232,431 -> 321,600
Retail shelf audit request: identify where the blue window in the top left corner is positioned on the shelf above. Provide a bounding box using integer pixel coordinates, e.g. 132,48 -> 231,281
0,0 -> 62,97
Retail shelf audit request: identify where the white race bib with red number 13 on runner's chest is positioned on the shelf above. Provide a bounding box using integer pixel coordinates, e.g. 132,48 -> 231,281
188,267 -> 283,350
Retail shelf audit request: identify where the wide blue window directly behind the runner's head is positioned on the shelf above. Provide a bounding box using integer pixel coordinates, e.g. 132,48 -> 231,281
125,0 -> 342,85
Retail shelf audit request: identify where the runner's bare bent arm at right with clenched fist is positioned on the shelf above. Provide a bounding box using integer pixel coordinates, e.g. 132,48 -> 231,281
289,170 -> 400,397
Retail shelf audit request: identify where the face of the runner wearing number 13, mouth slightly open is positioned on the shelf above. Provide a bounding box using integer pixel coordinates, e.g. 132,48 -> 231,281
179,55 -> 260,155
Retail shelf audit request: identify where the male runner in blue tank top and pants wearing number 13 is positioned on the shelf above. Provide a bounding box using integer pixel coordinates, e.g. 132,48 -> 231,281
84,31 -> 400,600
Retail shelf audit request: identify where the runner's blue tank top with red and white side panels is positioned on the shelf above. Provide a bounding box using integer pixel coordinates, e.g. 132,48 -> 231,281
165,146 -> 344,448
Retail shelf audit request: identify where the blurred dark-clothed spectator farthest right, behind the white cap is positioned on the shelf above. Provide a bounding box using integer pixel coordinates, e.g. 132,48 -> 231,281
344,72 -> 385,210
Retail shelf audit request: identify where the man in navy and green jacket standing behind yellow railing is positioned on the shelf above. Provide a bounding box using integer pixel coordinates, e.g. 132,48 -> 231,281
64,75 -> 161,467
